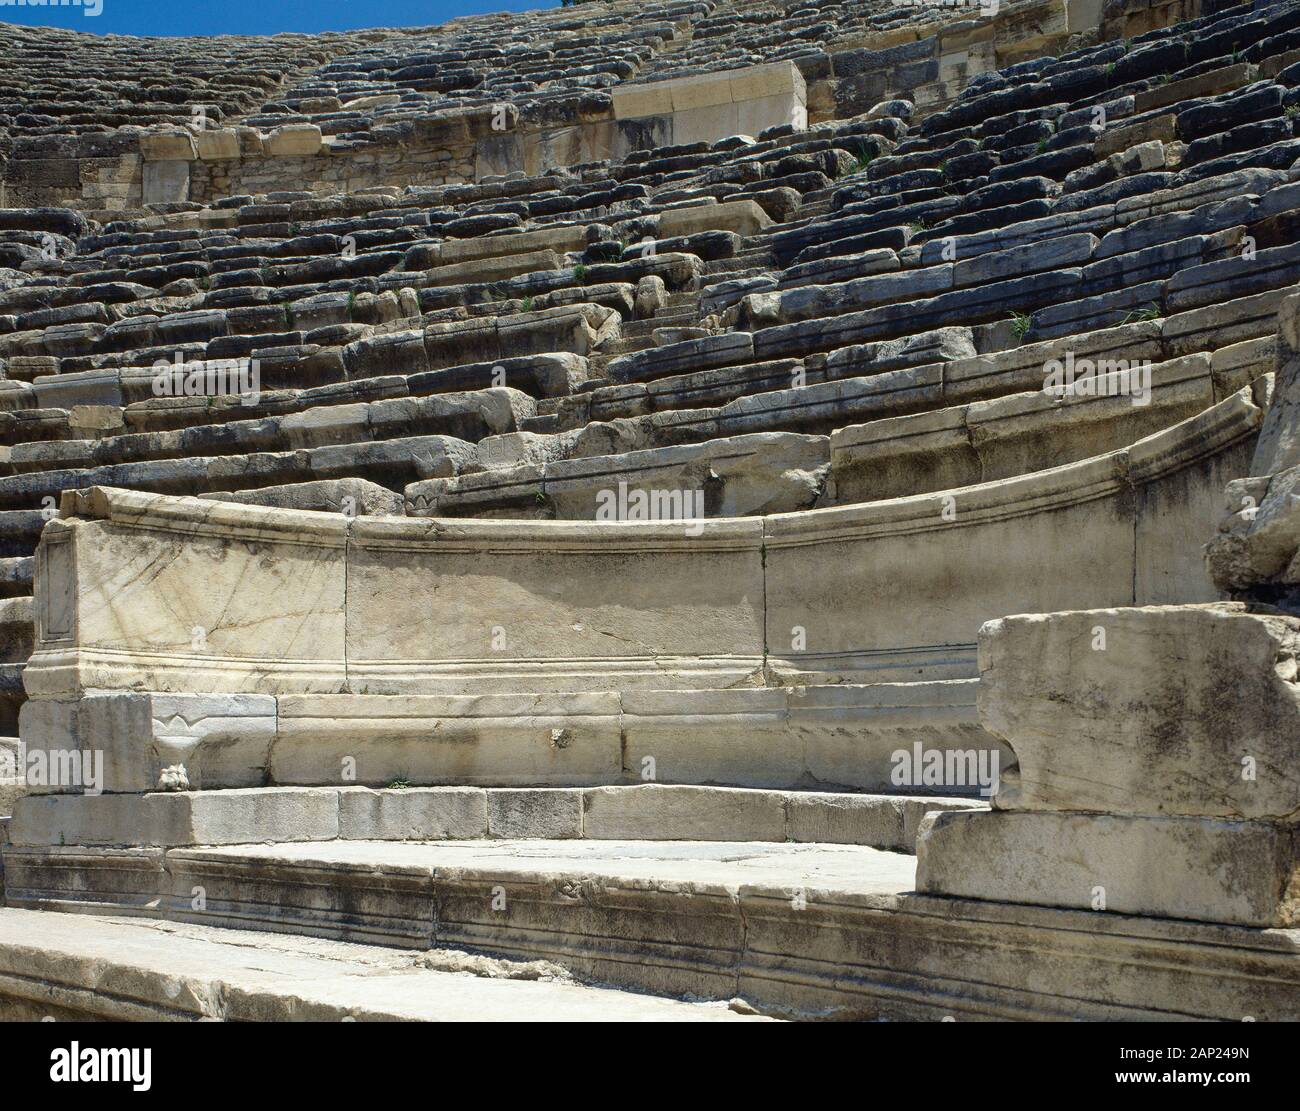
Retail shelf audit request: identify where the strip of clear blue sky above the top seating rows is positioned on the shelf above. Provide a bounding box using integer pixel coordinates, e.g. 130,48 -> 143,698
0,0 -> 559,35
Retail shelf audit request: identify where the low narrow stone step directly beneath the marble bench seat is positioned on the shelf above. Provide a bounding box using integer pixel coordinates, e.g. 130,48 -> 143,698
9,784 -> 987,852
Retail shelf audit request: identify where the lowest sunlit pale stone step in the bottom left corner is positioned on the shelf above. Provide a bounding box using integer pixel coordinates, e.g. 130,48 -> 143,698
0,908 -> 762,1023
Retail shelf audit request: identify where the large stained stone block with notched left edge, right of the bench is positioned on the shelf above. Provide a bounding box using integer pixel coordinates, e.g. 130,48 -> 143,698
979,603 -> 1300,821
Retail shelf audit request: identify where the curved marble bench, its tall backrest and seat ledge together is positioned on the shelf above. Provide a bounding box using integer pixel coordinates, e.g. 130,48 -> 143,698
12,390 -> 1261,795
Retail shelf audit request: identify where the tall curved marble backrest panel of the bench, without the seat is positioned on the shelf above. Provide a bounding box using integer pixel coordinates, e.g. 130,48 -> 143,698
25,390 -> 1260,698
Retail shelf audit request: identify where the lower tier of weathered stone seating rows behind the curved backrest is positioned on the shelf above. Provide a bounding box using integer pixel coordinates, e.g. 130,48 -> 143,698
0,0 -> 1300,758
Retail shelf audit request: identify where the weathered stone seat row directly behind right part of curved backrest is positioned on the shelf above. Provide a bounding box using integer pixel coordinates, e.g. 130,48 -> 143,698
406,350 -> 1273,520
